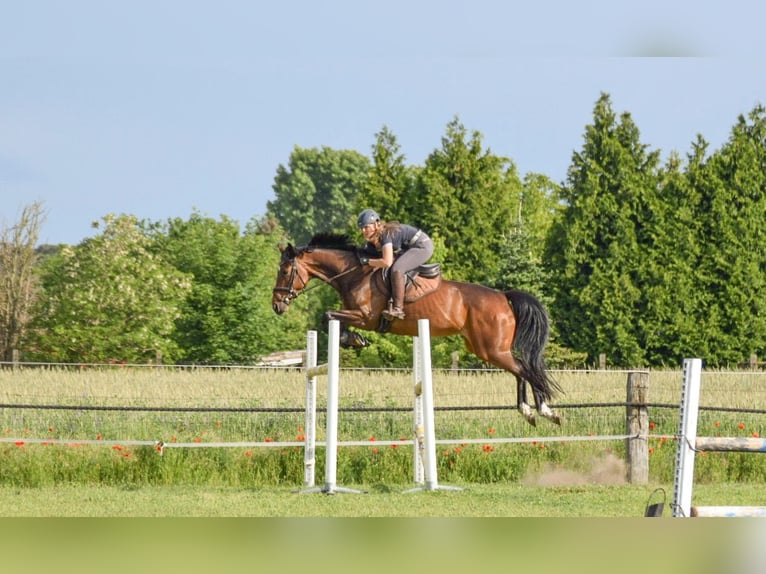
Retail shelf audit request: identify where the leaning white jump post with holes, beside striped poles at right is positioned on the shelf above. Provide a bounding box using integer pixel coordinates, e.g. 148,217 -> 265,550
673,359 -> 702,517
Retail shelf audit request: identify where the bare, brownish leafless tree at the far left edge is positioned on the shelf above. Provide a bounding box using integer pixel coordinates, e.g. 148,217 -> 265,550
0,202 -> 45,361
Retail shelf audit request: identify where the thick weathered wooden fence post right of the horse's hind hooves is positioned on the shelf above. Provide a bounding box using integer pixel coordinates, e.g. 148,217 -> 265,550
625,371 -> 649,484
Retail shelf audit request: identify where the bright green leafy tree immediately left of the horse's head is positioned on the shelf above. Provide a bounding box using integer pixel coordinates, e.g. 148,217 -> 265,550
155,212 -> 306,364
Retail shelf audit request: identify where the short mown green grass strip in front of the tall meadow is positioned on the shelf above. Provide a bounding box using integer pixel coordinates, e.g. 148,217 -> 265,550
0,483 -> 766,518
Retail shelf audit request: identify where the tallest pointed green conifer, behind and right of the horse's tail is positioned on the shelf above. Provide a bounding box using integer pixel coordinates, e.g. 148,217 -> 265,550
548,94 -> 659,366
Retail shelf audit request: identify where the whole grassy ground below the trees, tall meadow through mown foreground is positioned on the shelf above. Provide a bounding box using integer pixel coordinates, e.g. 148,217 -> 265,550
0,366 -> 766,516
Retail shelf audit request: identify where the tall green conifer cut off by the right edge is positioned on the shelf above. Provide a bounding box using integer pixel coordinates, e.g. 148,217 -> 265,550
696,105 -> 766,366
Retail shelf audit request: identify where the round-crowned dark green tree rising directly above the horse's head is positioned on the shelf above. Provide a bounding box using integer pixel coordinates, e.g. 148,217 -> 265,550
266,146 -> 370,245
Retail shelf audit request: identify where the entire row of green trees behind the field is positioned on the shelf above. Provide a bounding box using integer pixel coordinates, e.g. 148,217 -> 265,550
0,93 -> 766,367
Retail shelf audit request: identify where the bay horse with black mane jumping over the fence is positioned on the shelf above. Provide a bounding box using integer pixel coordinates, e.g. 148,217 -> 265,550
272,233 -> 562,425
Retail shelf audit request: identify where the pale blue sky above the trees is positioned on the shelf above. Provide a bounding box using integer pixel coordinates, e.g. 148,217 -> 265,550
0,0 -> 766,244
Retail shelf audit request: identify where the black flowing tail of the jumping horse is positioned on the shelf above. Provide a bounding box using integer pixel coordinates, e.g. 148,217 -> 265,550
505,291 -> 562,402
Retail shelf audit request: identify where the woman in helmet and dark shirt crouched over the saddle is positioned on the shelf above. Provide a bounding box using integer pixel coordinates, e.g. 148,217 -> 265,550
357,209 -> 434,321
